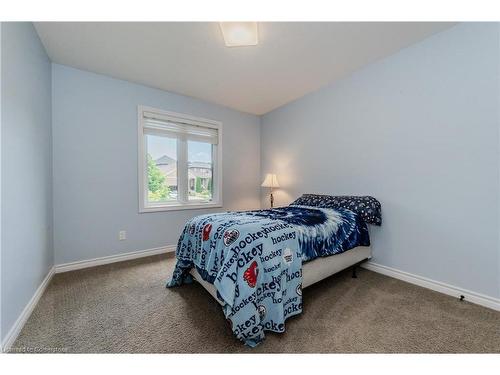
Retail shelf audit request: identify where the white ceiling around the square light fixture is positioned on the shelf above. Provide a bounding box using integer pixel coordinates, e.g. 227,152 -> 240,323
35,22 -> 454,115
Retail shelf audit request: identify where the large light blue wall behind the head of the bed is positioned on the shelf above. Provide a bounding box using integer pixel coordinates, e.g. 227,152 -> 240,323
261,23 -> 500,298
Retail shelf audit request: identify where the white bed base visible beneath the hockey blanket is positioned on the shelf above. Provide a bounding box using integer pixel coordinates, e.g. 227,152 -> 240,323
190,246 -> 372,304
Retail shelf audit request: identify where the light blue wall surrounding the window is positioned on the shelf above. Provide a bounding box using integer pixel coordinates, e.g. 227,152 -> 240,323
52,64 -> 260,264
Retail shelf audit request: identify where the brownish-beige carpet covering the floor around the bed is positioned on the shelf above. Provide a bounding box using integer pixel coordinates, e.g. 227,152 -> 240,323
13,256 -> 500,353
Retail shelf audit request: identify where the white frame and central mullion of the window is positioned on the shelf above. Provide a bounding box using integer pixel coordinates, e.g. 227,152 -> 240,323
137,105 -> 222,213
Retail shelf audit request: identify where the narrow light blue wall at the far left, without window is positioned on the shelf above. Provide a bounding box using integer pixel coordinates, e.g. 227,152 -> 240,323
1,22 -> 53,341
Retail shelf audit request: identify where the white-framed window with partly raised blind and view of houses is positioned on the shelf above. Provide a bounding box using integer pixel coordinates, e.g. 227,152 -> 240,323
139,106 -> 222,212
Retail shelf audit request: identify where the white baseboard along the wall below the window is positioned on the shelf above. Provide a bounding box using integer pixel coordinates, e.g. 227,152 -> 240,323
55,245 -> 176,273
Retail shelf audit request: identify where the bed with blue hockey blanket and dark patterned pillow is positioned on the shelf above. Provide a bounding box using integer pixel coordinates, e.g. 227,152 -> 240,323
167,194 -> 381,347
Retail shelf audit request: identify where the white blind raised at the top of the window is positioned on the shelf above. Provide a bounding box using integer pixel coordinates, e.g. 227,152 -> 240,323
143,112 -> 219,145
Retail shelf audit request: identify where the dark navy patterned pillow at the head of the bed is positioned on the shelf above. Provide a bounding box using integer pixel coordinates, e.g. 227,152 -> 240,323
291,194 -> 382,225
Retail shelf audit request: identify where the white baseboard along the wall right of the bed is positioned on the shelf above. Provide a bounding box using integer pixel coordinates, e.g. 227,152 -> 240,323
362,262 -> 500,311
